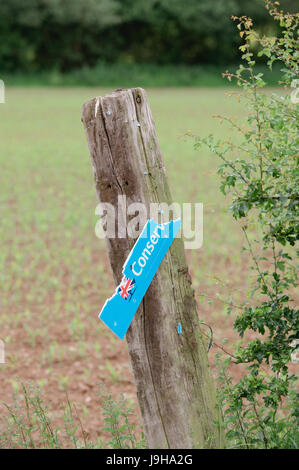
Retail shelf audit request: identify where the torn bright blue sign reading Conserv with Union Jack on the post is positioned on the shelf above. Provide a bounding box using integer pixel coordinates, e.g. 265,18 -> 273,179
99,219 -> 181,339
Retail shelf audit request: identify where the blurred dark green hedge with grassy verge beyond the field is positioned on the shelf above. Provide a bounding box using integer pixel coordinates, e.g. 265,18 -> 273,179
0,0 -> 296,86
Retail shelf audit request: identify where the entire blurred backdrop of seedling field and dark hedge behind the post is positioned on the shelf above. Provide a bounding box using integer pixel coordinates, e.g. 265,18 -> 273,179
0,0 -> 296,447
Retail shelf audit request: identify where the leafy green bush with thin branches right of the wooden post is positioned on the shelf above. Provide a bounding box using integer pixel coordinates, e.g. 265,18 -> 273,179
195,0 -> 299,448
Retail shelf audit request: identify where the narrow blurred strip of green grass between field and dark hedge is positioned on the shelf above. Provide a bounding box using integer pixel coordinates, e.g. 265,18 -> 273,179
0,63 -> 281,88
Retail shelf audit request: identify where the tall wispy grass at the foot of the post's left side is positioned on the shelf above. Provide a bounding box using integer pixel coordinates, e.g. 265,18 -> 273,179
0,382 -> 145,449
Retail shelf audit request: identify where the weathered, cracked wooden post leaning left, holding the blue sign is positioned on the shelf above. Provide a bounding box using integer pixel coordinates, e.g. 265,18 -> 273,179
82,88 -> 222,449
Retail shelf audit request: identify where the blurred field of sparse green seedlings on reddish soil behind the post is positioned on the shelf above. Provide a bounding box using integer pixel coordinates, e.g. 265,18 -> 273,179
0,87 -> 256,445
